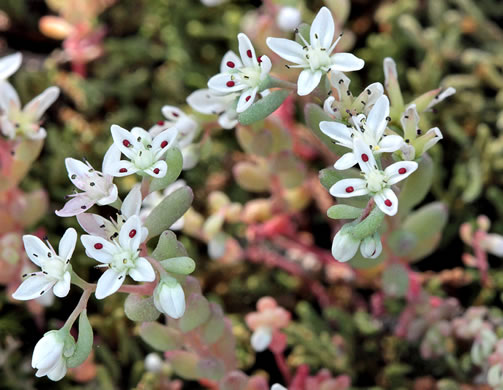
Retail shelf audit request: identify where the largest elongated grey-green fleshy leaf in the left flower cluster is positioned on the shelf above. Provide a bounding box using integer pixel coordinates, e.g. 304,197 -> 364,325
144,186 -> 194,238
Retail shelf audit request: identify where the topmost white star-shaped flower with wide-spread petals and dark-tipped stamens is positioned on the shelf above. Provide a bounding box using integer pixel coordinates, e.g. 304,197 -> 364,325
266,7 -> 365,96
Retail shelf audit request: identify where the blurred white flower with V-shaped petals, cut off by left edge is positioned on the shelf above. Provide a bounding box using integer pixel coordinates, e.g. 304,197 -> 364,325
0,81 -> 59,140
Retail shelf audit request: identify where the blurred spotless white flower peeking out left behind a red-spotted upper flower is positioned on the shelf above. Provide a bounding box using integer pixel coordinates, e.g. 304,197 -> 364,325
187,89 -> 239,129
